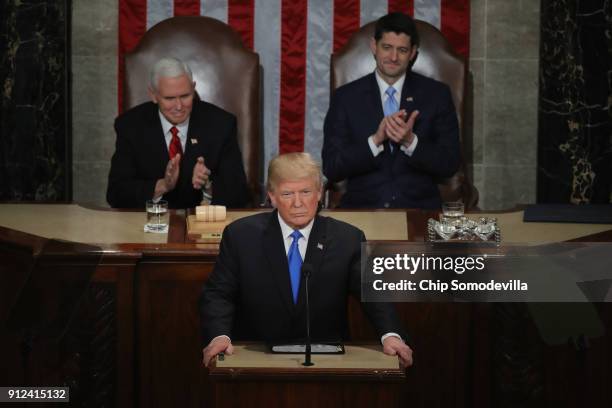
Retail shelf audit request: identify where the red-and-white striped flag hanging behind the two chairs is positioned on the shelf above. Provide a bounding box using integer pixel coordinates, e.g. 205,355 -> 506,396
119,0 -> 470,171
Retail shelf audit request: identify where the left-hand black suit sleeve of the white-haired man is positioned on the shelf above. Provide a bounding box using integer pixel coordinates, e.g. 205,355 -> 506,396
106,120 -> 157,208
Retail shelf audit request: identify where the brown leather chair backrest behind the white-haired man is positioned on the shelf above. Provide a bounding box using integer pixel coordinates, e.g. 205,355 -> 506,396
124,16 -> 262,202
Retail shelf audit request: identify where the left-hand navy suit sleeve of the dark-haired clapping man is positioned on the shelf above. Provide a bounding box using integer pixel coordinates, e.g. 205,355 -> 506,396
322,91 -> 382,182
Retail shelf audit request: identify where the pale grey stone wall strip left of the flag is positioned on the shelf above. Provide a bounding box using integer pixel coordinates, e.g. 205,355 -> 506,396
72,0 -> 119,206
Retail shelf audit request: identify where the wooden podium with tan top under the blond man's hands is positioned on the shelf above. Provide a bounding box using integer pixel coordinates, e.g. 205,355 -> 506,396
207,343 -> 407,408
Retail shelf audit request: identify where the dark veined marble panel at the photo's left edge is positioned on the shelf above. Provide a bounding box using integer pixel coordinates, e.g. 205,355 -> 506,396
0,0 -> 72,201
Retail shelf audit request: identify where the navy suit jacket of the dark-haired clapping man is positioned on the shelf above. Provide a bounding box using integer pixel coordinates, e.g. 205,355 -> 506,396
323,71 -> 460,208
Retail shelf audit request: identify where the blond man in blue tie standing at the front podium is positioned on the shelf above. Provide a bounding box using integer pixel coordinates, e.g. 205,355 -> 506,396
200,153 -> 412,366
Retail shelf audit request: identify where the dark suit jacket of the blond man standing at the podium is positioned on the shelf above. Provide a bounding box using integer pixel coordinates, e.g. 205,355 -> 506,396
200,211 -> 406,344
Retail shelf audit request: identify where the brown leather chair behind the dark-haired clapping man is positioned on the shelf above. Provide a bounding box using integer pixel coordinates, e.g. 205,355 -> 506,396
330,20 -> 478,208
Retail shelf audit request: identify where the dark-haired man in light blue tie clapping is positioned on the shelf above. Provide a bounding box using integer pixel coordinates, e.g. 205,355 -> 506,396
323,13 -> 460,208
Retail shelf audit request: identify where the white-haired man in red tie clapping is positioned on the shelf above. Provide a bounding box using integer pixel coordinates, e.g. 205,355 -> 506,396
106,58 -> 249,208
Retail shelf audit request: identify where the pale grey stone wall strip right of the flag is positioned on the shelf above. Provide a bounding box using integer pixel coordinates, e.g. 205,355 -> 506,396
468,0 -> 540,210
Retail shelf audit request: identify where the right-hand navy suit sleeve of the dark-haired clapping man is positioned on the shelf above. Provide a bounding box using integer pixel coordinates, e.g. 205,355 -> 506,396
405,86 -> 461,177
